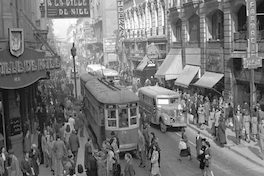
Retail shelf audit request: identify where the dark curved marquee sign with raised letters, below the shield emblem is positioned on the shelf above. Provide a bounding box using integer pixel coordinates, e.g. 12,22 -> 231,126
0,48 -> 61,89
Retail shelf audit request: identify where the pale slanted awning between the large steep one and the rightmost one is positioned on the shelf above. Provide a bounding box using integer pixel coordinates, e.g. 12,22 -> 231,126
175,65 -> 200,88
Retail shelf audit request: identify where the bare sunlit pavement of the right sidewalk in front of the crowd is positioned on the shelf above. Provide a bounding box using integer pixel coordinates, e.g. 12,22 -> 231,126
188,115 -> 264,167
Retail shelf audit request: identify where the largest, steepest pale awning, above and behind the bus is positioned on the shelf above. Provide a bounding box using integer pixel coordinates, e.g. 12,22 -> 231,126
155,49 -> 182,80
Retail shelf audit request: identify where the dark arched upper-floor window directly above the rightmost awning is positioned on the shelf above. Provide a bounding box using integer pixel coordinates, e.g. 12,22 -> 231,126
212,10 -> 224,40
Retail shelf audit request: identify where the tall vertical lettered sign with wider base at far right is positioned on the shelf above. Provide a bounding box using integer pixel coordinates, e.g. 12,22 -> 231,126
244,0 -> 262,69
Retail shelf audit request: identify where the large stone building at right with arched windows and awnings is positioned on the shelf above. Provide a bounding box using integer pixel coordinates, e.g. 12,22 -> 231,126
168,0 -> 264,106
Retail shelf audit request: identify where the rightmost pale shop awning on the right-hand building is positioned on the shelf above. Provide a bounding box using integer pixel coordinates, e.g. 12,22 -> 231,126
194,72 -> 224,89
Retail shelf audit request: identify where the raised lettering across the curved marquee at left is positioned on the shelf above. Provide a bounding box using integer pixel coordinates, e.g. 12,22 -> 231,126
0,58 -> 61,75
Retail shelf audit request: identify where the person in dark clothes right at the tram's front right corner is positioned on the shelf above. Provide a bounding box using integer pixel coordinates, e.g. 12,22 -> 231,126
138,130 -> 146,168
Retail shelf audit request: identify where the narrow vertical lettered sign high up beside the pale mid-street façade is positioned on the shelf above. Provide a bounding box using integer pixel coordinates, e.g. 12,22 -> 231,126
117,0 -> 126,41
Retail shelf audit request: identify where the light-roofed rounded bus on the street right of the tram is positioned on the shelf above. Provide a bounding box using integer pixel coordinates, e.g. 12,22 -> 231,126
138,86 -> 187,133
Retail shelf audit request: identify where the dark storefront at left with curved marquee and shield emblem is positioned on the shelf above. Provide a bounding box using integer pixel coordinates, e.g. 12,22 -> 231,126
0,30 -> 61,160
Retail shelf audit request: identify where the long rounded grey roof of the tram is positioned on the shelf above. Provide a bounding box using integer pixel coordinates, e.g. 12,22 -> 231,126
85,79 -> 139,104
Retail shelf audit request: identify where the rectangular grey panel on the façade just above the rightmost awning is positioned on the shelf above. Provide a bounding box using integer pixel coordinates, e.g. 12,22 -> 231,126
206,49 -> 224,73
